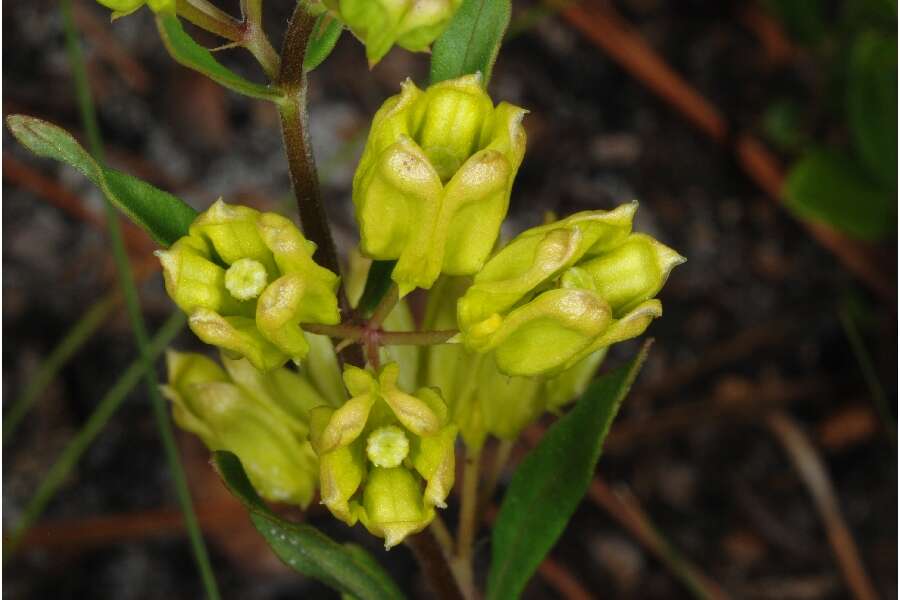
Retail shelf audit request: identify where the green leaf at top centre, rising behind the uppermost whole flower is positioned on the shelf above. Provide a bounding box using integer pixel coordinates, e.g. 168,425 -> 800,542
431,0 -> 511,87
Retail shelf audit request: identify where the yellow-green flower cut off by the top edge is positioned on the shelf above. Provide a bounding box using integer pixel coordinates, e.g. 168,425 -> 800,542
324,0 -> 462,67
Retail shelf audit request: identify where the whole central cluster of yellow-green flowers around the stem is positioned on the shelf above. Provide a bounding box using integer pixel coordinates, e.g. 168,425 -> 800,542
158,72 -> 684,547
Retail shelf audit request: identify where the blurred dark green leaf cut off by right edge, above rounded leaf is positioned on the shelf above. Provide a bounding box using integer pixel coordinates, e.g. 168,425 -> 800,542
847,32 -> 897,188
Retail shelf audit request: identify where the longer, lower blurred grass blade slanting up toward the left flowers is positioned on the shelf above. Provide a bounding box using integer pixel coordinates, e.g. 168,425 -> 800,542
3,312 -> 185,562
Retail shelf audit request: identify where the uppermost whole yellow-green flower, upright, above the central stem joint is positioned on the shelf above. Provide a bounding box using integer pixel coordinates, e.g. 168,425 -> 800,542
353,75 -> 525,295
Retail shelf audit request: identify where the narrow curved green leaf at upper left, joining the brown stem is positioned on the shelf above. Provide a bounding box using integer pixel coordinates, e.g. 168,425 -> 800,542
156,13 -> 284,102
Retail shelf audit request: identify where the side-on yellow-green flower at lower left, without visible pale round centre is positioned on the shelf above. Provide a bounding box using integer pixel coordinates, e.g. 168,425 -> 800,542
162,351 -> 325,508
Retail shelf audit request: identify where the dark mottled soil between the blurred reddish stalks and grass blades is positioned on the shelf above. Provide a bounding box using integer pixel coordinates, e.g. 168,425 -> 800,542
3,0 -> 897,600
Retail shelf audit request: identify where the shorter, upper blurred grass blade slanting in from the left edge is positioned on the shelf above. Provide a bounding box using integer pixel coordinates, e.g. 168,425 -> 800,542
3,294 -> 118,445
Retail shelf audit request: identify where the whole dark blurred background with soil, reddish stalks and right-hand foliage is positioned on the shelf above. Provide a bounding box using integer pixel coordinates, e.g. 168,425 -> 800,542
2,0 -> 897,600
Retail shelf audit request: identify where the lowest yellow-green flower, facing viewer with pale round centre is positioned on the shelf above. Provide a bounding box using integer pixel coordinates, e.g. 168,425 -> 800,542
311,363 -> 457,548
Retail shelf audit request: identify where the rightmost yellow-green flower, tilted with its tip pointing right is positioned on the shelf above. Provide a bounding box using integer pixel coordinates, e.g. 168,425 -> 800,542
457,204 -> 684,376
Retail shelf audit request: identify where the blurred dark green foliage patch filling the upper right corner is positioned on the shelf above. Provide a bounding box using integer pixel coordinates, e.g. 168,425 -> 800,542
762,0 -> 897,240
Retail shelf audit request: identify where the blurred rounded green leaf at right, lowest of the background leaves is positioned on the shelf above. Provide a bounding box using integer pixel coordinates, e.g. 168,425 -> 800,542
784,148 -> 897,240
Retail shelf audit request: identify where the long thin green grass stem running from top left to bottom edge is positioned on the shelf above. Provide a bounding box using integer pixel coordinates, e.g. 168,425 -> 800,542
60,0 -> 219,600
